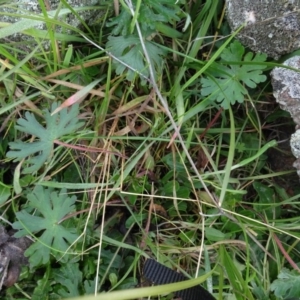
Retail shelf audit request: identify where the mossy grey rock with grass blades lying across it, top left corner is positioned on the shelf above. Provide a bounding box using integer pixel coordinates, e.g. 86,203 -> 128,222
0,0 -> 101,54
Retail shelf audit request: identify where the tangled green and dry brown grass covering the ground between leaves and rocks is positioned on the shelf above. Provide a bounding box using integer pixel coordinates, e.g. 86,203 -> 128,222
0,1 -> 300,300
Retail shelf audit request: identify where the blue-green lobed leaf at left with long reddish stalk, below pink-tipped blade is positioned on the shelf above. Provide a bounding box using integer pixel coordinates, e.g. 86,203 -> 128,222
6,103 -> 83,174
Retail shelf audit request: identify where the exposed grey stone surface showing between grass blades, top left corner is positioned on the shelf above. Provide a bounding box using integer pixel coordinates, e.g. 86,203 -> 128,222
0,0 -> 101,52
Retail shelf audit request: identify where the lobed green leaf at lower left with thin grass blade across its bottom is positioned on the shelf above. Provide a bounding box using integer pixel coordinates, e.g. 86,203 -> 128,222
13,186 -> 78,267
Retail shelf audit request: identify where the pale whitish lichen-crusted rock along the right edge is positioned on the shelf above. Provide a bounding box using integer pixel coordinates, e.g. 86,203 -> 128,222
271,56 -> 300,176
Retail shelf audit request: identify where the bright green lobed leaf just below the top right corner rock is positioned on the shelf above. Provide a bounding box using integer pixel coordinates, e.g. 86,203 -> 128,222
201,41 -> 267,109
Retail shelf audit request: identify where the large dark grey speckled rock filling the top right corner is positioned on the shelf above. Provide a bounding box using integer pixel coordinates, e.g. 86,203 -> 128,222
226,0 -> 300,59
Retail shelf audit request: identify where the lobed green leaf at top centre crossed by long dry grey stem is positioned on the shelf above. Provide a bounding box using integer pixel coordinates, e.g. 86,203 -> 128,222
107,35 -> 164,84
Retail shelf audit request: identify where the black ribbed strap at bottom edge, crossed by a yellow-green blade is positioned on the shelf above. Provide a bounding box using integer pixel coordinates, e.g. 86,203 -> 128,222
144,259 -> 215,300
